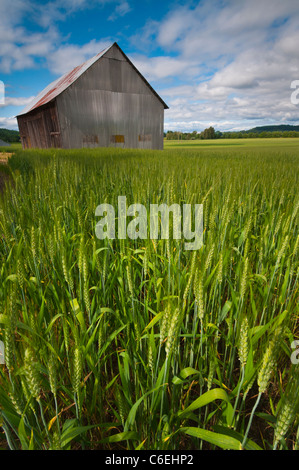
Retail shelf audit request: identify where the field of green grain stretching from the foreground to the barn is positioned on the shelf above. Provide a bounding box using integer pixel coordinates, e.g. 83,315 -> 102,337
0,144 -> 299,450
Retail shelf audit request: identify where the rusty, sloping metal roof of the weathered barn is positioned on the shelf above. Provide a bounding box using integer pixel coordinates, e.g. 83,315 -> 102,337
18,43 -> 168,116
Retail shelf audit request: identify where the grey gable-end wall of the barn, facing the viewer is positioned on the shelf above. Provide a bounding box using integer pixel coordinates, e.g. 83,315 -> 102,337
57,47 -> 164,149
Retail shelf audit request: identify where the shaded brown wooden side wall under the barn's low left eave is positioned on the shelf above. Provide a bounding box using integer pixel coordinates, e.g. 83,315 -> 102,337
17,102 -> 61,148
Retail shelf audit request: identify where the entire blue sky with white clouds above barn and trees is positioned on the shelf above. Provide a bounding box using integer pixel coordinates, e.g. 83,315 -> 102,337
0,0 -> 299,131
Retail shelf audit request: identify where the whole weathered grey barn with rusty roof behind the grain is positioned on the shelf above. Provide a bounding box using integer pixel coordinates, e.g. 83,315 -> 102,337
17,43 -> 168,150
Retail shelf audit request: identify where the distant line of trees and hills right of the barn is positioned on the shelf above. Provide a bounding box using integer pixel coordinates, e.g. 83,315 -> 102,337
164,127 -> 299,140
